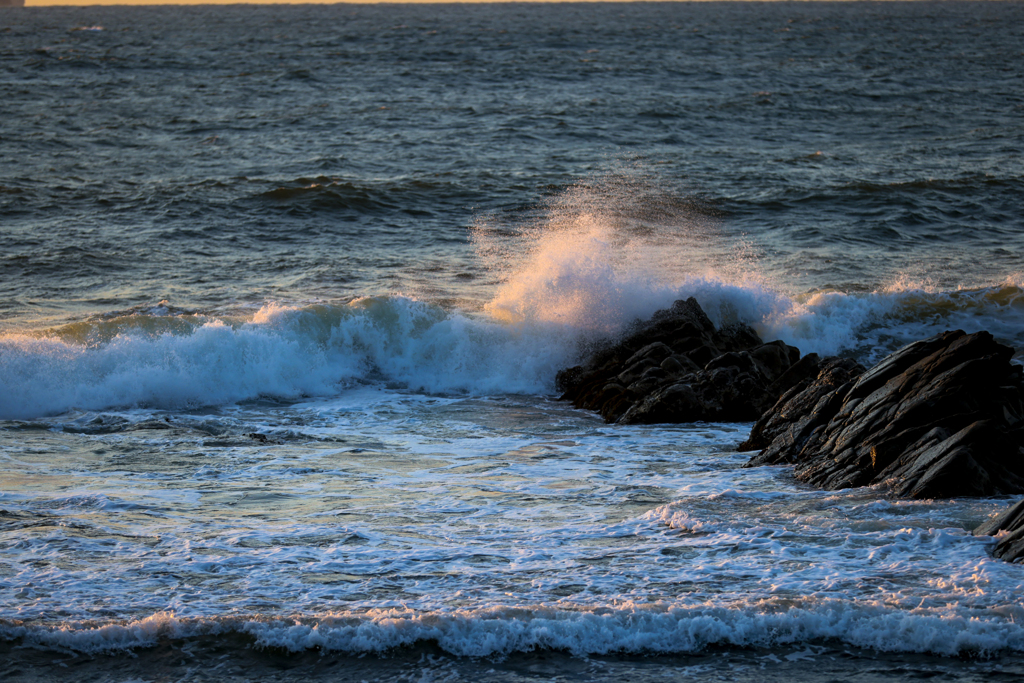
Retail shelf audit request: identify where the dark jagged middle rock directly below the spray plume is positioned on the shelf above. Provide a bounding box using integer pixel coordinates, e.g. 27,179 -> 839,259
556,298 -> 817,424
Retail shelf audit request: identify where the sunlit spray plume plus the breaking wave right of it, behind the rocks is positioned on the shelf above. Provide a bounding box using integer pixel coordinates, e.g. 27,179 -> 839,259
474,163 -> 1024,364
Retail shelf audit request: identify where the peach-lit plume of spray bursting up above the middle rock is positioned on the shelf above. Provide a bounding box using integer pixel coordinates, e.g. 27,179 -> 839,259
474,168 -> 757,336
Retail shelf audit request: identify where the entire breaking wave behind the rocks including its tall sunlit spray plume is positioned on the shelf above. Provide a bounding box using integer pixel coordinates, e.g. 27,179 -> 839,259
0,166 -> 1024,419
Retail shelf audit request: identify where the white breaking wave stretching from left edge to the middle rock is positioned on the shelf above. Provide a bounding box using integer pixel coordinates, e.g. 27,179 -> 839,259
0,297 -> 575,420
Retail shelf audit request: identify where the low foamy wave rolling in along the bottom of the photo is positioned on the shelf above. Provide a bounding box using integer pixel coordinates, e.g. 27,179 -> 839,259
0,600 -> 1024,657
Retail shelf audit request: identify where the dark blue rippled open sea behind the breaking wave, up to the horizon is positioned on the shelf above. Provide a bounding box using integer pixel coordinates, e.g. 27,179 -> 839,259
0,2 -> 1024,324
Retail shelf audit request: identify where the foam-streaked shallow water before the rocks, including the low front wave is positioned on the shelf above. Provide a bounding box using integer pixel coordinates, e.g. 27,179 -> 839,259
0,393 -> 1024,656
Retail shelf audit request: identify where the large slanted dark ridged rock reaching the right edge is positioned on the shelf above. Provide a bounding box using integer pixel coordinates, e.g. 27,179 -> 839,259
741,331 -> 1024,498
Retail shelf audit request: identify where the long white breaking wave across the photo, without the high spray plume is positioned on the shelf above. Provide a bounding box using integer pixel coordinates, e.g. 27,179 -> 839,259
0,275 -> 1024,420
